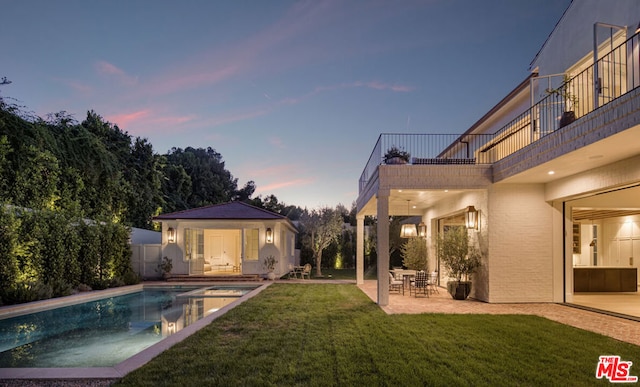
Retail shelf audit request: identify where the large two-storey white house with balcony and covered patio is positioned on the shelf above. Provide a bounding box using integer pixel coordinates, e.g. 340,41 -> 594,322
357,0 -> 640,316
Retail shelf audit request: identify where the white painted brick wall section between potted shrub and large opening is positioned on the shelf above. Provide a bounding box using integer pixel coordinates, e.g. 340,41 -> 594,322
487,184 -> 561,302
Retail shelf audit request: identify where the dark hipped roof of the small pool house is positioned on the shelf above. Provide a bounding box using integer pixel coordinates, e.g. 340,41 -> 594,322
153,202 -> 289,221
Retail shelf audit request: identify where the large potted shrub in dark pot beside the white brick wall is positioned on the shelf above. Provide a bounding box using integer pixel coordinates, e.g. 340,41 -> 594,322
438,226 -> 482,300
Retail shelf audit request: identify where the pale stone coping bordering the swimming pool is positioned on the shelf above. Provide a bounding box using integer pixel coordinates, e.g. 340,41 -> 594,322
0,281 -> 273,380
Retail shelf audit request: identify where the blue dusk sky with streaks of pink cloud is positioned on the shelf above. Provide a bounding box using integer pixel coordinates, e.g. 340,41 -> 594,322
0,0 -> 570,208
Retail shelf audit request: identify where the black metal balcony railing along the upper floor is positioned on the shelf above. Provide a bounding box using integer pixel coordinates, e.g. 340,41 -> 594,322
359,30 -> 640,191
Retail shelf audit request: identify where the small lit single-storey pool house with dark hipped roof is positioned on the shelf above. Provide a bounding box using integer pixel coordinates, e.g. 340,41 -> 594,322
154,202 -> 298,276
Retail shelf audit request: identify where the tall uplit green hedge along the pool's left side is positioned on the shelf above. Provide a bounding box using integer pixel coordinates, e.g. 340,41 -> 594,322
0,206 -> 138,304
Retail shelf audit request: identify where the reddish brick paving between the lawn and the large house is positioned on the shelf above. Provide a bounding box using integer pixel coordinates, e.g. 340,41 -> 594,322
359,280 -> 640,346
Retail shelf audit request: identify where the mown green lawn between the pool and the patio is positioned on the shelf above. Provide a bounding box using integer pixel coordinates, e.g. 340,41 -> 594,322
117,283 -> 640,386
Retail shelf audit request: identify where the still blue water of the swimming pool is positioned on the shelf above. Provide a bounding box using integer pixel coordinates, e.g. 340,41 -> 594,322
0,286 -> 256,368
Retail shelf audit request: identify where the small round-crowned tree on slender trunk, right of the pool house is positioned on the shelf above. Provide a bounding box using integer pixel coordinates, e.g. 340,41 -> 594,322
301,207 -> 343,276
